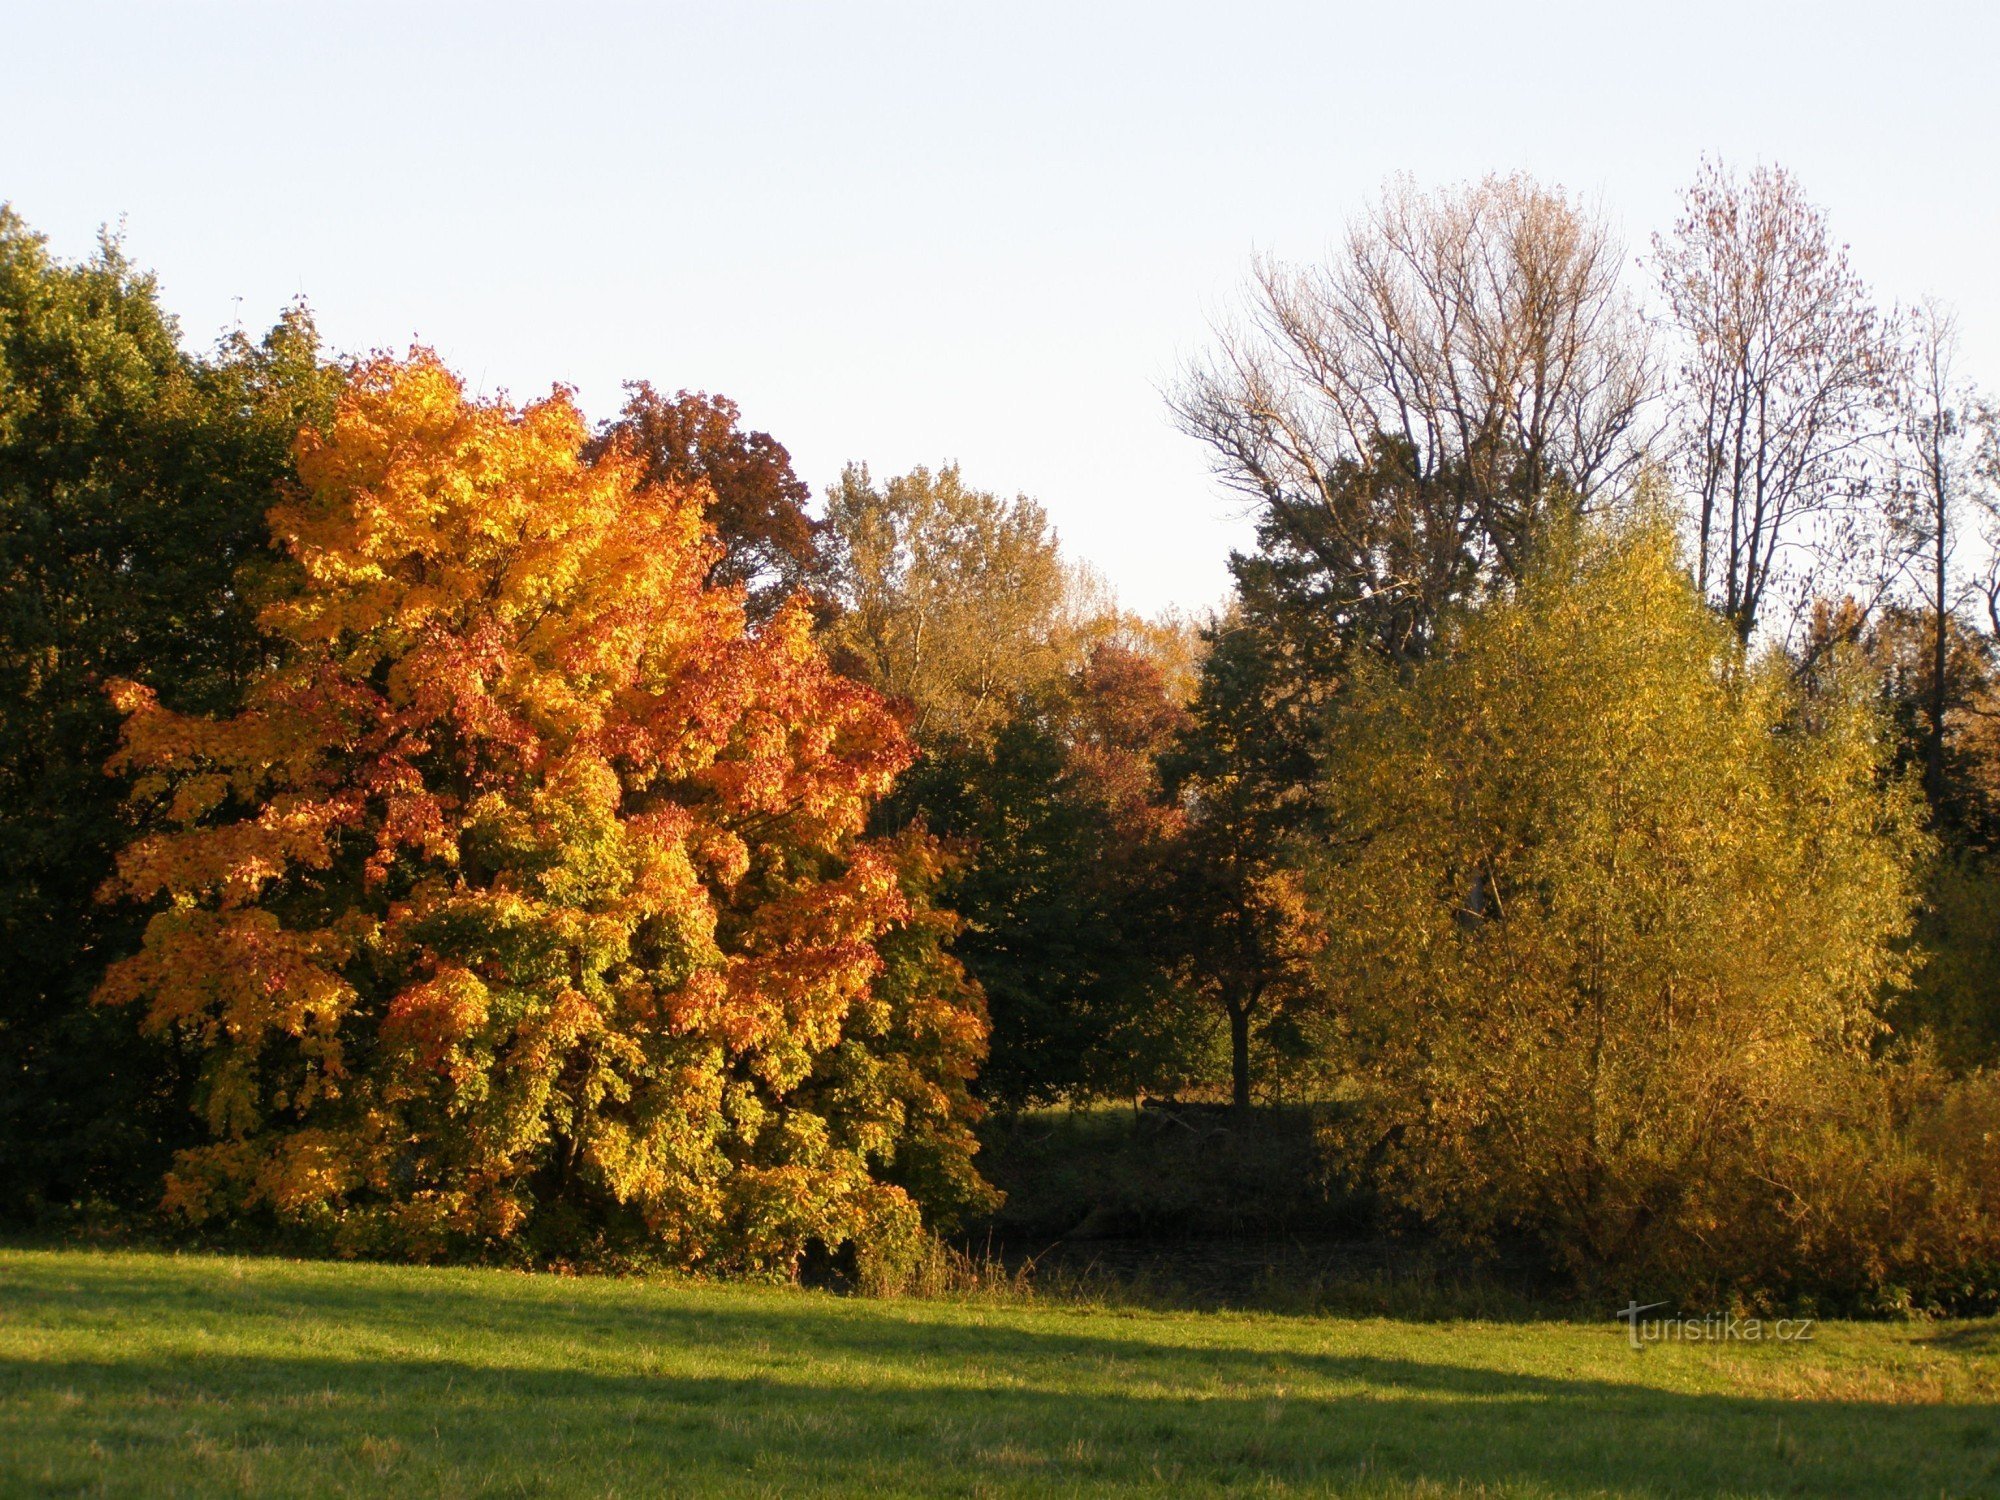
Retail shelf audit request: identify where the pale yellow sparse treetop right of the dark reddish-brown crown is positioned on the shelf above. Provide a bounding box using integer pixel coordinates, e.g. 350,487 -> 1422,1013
826,464 -> 1088,744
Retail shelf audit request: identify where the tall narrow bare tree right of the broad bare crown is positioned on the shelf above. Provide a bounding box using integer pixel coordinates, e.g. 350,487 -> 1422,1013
1654,162 -> 1896,640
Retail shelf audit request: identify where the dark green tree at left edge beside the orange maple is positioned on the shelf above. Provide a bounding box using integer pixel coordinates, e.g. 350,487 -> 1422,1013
0,206 -> 338,1218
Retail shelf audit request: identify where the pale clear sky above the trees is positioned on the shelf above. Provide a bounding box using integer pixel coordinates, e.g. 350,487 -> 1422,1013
0,0 -> 2000,612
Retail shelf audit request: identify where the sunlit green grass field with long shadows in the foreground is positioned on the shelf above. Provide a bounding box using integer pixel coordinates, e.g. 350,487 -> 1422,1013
0,1250 -> 2000,1498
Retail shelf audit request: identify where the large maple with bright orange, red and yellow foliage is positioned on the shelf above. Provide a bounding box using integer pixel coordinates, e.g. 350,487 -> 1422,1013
100,352 -> 988,1270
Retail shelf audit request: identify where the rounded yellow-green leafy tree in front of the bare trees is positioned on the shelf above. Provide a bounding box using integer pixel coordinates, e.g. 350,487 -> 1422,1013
1308,518 -> 1926,1288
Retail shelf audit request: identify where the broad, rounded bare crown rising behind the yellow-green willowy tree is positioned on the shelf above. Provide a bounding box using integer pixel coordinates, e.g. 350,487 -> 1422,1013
1170,176 -> 1652,654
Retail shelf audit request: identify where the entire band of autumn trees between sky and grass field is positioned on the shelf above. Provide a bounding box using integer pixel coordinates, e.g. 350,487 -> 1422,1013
0,166 -> 2000,1308
